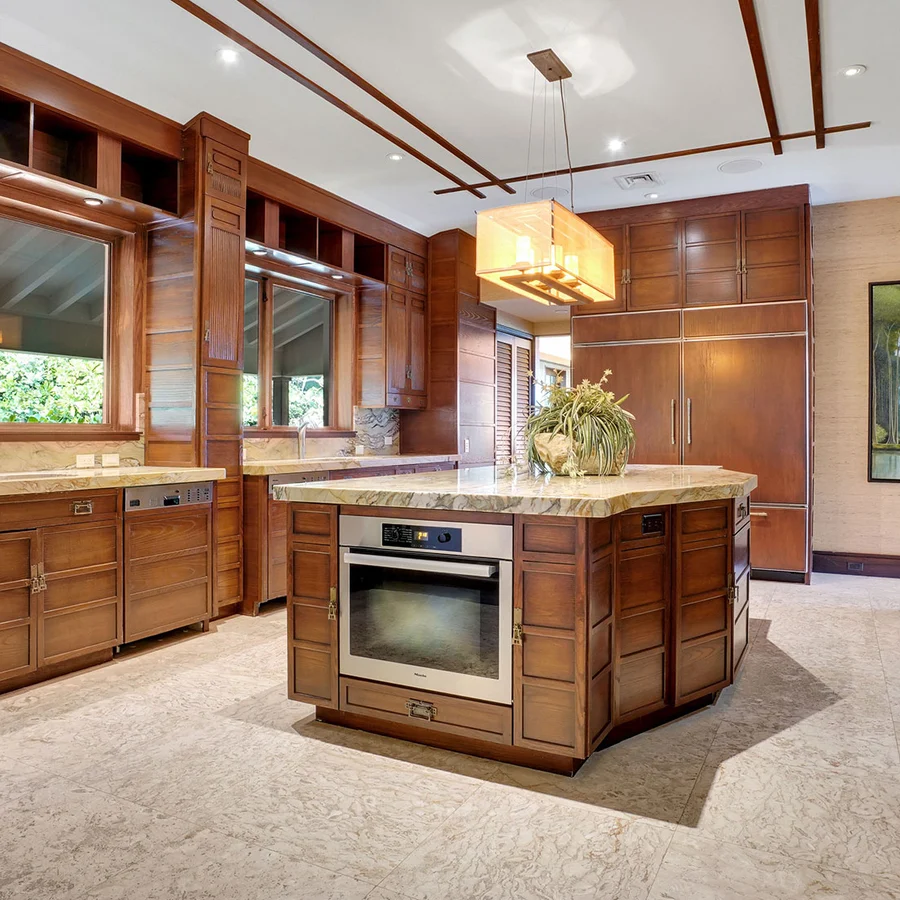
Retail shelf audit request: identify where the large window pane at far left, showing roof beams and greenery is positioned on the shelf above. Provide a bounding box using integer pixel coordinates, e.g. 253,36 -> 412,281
0,218 -> 109,424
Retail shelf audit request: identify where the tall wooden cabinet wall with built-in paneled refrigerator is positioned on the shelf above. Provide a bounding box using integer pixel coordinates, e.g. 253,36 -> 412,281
572,186 -> 812,577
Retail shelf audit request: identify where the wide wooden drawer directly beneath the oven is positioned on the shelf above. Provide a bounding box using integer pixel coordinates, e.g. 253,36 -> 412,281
340,677 -> 512,744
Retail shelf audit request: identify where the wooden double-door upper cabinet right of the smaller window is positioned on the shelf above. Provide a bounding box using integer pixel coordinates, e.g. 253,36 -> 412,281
357,285 -> 428,409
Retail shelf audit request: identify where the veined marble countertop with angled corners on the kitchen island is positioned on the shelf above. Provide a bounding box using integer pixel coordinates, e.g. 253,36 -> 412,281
275,466 -> 757,519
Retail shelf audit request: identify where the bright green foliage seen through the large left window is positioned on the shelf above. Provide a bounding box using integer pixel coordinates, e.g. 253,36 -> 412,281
0,351 -> 103,424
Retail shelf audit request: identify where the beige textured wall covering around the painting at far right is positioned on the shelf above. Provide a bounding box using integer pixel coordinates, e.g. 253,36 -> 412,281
813,197 -> 900,555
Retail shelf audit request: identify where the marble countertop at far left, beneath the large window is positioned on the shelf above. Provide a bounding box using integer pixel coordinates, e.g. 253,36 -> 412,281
0,466 -> 225,497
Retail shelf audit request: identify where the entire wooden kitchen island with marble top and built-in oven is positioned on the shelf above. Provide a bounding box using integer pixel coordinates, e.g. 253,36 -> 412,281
275,466 -> 756,773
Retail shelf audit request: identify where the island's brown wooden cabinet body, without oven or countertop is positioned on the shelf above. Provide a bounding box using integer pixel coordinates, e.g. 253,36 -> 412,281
285,497 -> 750,768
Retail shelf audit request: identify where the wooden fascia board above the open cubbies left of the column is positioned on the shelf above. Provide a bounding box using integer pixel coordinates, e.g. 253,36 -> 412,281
0,43 -> 181,159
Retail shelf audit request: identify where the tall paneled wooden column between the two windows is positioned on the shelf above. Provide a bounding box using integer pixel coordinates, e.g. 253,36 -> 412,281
145,113 -> 249,612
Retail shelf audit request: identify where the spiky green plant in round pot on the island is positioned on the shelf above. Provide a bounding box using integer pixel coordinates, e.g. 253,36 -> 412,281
525,369 -> 635,476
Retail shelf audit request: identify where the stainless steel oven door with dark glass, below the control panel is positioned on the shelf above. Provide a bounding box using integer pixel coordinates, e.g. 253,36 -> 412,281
341,548 -> 512,703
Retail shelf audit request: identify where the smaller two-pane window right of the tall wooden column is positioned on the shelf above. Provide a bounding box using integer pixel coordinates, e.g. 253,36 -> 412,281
243,278 -> 332,428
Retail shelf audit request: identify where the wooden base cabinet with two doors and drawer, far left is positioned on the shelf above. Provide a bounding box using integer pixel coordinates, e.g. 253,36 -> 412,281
0,491 -> 122,682
